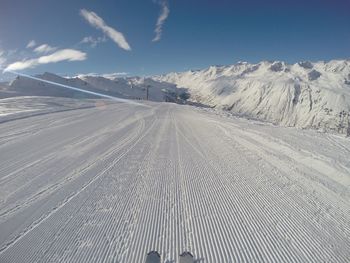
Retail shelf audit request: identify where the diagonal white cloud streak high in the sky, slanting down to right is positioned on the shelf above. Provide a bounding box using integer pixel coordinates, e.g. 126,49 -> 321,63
80,9 -> 131,50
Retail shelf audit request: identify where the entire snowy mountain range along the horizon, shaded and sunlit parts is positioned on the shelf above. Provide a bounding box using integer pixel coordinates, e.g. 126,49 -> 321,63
0,60 -> 350,135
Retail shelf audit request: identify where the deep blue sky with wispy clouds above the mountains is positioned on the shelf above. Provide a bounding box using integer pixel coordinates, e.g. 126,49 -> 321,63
0,0 -> 350,79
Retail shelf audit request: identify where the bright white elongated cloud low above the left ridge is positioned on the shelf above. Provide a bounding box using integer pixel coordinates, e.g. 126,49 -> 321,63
4,49 -> 87,71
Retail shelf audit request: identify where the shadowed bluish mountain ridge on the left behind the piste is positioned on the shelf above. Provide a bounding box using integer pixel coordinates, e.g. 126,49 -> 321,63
6,73 -> 181,102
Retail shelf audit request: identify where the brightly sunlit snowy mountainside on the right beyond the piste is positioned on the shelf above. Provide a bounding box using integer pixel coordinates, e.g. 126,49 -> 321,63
155,60 -> 350,135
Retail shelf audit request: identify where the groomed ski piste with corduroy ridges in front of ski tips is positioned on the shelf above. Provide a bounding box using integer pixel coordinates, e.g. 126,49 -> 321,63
0,99 -> 350,263
